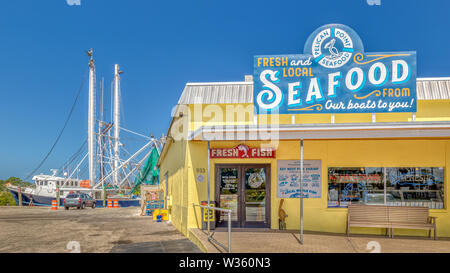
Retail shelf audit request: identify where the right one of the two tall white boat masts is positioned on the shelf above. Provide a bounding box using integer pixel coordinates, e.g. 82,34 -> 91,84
113,64 -> 122,185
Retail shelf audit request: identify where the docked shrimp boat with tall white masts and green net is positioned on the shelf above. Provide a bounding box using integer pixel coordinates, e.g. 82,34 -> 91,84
8,49 -> 165,207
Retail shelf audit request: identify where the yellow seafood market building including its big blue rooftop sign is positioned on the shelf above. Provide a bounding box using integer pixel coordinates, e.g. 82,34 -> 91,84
158,25 -> 450,237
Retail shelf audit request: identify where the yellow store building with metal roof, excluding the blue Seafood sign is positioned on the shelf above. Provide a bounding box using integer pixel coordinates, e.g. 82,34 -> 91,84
158,76 -> 450,240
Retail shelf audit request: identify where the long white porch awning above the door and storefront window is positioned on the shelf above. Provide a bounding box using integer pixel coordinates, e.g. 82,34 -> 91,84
189,121 -> 450,141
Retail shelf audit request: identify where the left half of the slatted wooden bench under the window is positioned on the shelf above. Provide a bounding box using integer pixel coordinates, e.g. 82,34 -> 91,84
347,205 -> 391,236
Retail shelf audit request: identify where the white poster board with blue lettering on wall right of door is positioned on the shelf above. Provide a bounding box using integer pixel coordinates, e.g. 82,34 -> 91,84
277,160 -> 322,198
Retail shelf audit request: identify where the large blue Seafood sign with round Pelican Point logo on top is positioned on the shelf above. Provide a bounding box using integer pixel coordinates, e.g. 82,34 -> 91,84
253,24 -> 417,114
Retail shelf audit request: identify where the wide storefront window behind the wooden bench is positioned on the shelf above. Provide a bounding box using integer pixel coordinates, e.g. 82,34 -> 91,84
328,167 -> 444,209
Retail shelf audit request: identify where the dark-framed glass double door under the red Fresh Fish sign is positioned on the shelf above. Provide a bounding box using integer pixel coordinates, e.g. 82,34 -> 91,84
215,164 -> 270,228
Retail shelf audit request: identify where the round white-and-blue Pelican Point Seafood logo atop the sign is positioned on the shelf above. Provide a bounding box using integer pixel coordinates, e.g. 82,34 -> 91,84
312,27 -> 354,68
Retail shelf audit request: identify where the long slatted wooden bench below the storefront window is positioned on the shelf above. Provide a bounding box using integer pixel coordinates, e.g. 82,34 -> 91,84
347,205 -> 436,239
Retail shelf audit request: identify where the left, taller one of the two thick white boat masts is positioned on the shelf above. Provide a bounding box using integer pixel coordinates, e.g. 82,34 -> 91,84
88,48 -> 95,187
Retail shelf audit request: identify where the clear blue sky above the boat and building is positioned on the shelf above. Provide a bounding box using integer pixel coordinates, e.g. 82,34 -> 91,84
0,0 -> 450,179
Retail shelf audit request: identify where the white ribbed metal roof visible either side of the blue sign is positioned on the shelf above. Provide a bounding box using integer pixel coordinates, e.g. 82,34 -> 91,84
178,77 -> 450,104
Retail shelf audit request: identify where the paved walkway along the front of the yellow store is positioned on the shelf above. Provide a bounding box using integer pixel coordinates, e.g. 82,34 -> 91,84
190,226 -> 450,253
